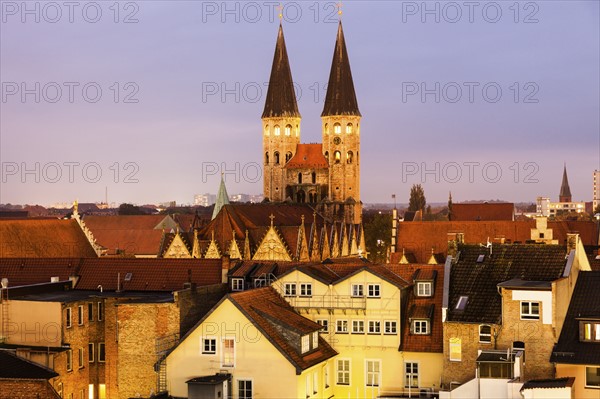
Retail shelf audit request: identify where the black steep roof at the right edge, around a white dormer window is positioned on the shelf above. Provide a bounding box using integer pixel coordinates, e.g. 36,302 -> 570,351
550,271 -> 600,365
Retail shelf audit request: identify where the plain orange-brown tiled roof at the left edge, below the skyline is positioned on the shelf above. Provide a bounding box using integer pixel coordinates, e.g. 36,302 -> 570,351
0,219 -> 97,258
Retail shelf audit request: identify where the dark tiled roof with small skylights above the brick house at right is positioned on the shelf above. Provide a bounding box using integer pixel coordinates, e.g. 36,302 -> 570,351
447,244 -> 567,323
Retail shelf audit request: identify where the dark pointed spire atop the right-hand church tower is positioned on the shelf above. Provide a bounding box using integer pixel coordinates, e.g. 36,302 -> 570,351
321,20 -> 361,116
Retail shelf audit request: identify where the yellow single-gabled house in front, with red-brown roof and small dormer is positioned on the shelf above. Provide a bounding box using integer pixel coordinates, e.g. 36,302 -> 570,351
165,287 -> 336,399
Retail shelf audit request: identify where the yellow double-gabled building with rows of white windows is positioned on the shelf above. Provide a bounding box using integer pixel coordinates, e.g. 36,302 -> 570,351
273,259 -> 409,398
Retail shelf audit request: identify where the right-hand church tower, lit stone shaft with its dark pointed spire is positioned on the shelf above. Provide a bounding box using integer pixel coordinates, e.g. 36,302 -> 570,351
321,20 -> 362,224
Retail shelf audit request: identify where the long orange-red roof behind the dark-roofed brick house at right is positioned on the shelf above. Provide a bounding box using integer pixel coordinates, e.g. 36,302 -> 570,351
390,220 -> 598,263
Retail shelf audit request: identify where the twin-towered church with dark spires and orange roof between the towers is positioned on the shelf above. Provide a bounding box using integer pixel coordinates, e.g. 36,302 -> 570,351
262,21 -> 362,224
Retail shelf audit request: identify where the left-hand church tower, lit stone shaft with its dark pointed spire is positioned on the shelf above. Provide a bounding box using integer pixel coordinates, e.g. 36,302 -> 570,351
262,24 -> 301,202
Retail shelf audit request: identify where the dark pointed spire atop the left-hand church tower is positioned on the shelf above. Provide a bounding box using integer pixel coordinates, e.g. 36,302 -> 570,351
262,24 -> 300,118
